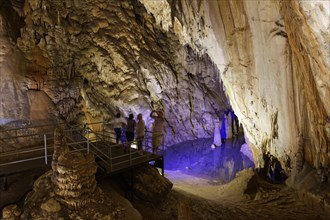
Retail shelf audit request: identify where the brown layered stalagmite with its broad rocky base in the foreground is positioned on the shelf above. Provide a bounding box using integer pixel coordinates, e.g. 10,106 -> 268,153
3,129 -> 125,219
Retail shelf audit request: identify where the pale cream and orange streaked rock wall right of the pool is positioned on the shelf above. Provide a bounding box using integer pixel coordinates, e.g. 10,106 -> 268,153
164,0 -> 330,170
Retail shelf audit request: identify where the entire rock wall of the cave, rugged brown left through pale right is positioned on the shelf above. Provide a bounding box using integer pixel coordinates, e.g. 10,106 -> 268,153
0,0 -> 330,174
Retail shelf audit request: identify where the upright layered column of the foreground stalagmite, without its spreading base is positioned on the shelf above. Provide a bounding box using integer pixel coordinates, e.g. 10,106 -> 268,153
52,130 -> 97,210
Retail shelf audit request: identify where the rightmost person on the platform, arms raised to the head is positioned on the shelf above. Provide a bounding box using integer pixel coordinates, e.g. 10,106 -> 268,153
150,110 -> 165,153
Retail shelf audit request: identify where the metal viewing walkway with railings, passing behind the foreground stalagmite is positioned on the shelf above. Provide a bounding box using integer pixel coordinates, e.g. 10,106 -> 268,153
0,123 -> 164,180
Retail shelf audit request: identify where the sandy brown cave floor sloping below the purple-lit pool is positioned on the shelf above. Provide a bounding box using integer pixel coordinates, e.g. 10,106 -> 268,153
127,169 -> 329,220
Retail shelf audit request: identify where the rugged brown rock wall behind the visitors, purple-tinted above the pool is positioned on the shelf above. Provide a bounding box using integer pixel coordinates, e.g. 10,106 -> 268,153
9,0 -> 229,144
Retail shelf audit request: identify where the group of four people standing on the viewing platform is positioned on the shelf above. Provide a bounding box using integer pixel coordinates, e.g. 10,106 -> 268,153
112,111 -> 165,153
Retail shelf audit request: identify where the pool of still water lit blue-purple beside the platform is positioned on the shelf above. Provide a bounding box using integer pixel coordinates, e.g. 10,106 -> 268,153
164,136 -> 254,183
